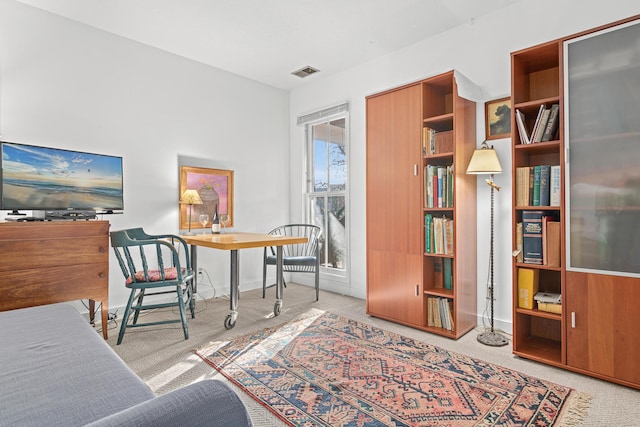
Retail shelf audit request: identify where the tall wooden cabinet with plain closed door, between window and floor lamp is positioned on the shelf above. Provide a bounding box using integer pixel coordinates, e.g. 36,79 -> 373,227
367,71 -> 477,338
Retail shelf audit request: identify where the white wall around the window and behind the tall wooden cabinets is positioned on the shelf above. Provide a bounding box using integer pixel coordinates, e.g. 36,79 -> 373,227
290,0 -> 640,331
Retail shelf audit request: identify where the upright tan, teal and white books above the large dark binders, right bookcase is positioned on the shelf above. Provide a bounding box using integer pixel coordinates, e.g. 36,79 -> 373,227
516,165 -> 561,206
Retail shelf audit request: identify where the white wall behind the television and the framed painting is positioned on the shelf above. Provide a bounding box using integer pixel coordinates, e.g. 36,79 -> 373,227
0,0 -> 289,314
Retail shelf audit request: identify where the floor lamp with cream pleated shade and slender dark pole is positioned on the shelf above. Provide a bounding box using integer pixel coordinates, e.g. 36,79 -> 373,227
467,141 -> 507,347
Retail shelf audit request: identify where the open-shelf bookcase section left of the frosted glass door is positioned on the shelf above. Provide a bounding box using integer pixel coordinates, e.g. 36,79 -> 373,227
511,41 -> 566,365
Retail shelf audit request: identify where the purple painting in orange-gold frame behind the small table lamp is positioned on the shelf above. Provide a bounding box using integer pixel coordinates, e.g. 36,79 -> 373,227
178,166 -> 233,229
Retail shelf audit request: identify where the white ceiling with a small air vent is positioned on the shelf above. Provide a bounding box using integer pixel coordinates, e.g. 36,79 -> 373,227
19,0 -> 521,90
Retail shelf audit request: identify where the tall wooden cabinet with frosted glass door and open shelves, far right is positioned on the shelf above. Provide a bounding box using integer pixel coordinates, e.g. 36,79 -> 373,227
511,16 -> 640,388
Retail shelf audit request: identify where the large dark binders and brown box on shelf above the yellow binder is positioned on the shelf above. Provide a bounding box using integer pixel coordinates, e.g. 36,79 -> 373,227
516,211 -> 561,267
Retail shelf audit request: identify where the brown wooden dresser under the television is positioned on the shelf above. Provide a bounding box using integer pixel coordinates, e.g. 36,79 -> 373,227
0,221 -> 110,339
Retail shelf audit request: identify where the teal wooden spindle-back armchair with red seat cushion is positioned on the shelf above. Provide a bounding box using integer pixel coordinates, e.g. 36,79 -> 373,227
110,228 -> 195,345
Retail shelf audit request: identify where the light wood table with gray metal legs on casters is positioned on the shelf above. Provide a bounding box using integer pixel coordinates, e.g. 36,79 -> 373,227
181,233 -> 308,329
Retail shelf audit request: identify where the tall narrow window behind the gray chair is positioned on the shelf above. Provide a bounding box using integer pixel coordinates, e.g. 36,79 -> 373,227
305,107 -> 348,276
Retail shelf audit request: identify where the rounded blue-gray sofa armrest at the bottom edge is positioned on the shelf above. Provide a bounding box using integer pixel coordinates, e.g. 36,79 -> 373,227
87,380 -> 252,427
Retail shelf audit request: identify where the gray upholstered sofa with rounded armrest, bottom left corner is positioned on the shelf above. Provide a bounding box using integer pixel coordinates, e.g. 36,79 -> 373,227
0,304 -> 251,427
